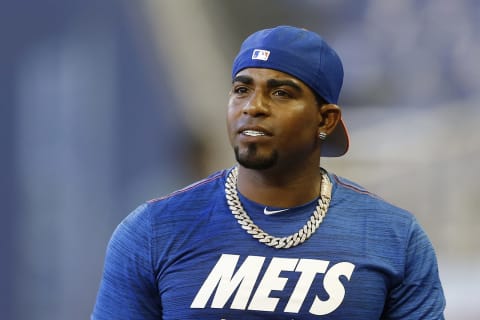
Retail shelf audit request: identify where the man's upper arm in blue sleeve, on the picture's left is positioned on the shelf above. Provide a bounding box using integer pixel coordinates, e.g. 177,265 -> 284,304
91,205 -> 162,320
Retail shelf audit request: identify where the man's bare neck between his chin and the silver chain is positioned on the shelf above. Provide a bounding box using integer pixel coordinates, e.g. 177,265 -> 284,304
237,165 -> 322,208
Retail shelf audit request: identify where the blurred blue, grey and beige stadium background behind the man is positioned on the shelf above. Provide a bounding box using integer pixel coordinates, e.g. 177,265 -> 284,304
0,0 -> 480,320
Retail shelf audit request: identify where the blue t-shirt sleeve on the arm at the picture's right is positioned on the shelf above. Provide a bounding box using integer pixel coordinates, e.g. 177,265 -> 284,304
382,221 -> 445,320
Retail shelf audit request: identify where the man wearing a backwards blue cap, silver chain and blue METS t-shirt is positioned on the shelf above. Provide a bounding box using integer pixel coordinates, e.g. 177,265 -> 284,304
92,26 -> 445,320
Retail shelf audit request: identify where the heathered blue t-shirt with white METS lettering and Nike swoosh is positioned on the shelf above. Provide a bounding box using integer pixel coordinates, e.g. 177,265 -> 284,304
92,170 -> 445,320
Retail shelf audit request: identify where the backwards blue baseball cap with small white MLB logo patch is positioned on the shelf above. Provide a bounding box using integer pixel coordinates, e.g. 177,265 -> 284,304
232,26 -> 349,157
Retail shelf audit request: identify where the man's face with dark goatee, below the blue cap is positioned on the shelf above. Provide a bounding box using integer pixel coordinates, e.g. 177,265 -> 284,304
227,68 -> 322,170
